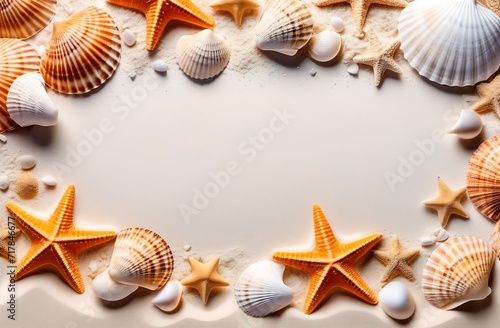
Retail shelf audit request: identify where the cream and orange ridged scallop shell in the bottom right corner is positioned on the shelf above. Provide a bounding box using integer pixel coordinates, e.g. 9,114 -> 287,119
422,236 -> 496,310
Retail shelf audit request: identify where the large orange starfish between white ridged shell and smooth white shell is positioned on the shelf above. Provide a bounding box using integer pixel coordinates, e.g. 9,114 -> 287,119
273,204 -> 382,314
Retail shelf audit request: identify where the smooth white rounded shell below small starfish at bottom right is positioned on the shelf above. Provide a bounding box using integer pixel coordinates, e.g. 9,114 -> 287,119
379,281 -> 416,320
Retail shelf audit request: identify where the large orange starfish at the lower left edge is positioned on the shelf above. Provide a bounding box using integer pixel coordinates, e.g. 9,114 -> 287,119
7,185 -> 116,294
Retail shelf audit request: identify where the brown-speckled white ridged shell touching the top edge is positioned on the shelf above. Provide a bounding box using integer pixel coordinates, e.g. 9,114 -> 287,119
255,0 -> 313,56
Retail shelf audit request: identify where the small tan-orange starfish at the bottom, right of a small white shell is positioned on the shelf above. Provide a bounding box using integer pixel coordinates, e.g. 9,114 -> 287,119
181,256 -> 229,304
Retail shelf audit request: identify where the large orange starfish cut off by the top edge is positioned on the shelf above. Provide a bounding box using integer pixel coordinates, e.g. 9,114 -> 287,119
107,0 -> 215,50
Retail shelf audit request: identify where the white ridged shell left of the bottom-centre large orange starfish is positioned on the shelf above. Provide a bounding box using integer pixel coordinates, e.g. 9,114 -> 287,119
234,261 -> 293,317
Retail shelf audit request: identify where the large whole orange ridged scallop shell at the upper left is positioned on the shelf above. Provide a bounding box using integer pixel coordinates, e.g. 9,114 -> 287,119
40,6 -> 121,94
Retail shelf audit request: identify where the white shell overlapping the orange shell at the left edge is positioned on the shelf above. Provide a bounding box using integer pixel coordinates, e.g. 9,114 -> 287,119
6,72 -> 58,127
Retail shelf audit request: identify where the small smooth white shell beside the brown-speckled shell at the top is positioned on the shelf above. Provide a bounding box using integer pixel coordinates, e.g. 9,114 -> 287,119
308,31 -> 342,62
